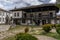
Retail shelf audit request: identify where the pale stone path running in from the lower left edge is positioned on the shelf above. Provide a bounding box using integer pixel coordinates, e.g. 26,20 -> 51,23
0,29 -> 24,40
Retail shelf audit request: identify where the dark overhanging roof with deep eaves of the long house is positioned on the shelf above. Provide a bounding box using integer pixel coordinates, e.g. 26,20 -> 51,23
10,4 -> 59,13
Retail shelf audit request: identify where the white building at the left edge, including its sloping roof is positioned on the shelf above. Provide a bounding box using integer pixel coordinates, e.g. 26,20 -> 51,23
0,8 -> 9,24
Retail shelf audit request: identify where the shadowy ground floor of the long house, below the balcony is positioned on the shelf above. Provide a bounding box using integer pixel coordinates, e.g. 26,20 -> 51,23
13,19 -> 57,25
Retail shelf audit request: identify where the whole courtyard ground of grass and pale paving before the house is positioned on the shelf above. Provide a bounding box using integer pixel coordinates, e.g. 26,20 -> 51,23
0,25 -> 60,40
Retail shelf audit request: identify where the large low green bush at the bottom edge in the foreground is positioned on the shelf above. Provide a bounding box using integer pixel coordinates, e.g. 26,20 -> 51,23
16,33 -> 37,40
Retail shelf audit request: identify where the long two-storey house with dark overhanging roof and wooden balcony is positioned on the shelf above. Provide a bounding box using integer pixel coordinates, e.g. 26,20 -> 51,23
10,4 -> 59,25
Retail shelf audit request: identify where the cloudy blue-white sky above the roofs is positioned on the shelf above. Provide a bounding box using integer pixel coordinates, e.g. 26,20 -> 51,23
0,0 -> 56,10
